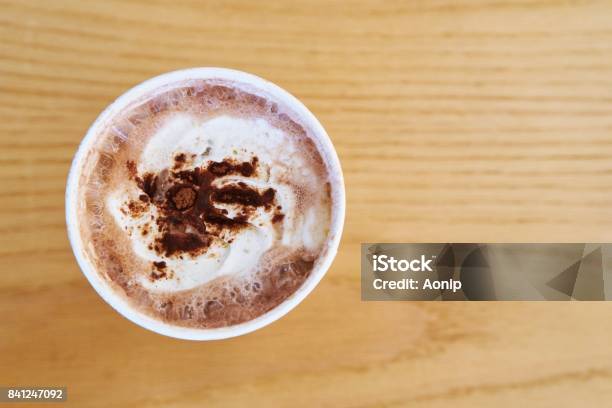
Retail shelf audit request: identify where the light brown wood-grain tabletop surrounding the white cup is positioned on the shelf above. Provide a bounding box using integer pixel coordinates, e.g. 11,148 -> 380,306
0,0 -> 612,407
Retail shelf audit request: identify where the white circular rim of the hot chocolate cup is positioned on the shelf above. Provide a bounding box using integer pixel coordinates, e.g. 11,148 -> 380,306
65,67 -> 346,340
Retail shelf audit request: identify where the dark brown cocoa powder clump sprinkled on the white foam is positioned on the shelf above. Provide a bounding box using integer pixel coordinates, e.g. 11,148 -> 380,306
128,153 -> 284,258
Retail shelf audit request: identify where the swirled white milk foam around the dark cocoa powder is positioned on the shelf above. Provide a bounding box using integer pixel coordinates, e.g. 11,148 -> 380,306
106,112 -> 330,293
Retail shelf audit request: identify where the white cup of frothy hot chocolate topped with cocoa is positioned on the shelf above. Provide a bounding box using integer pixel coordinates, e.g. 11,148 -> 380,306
66,68 -> 345,340
